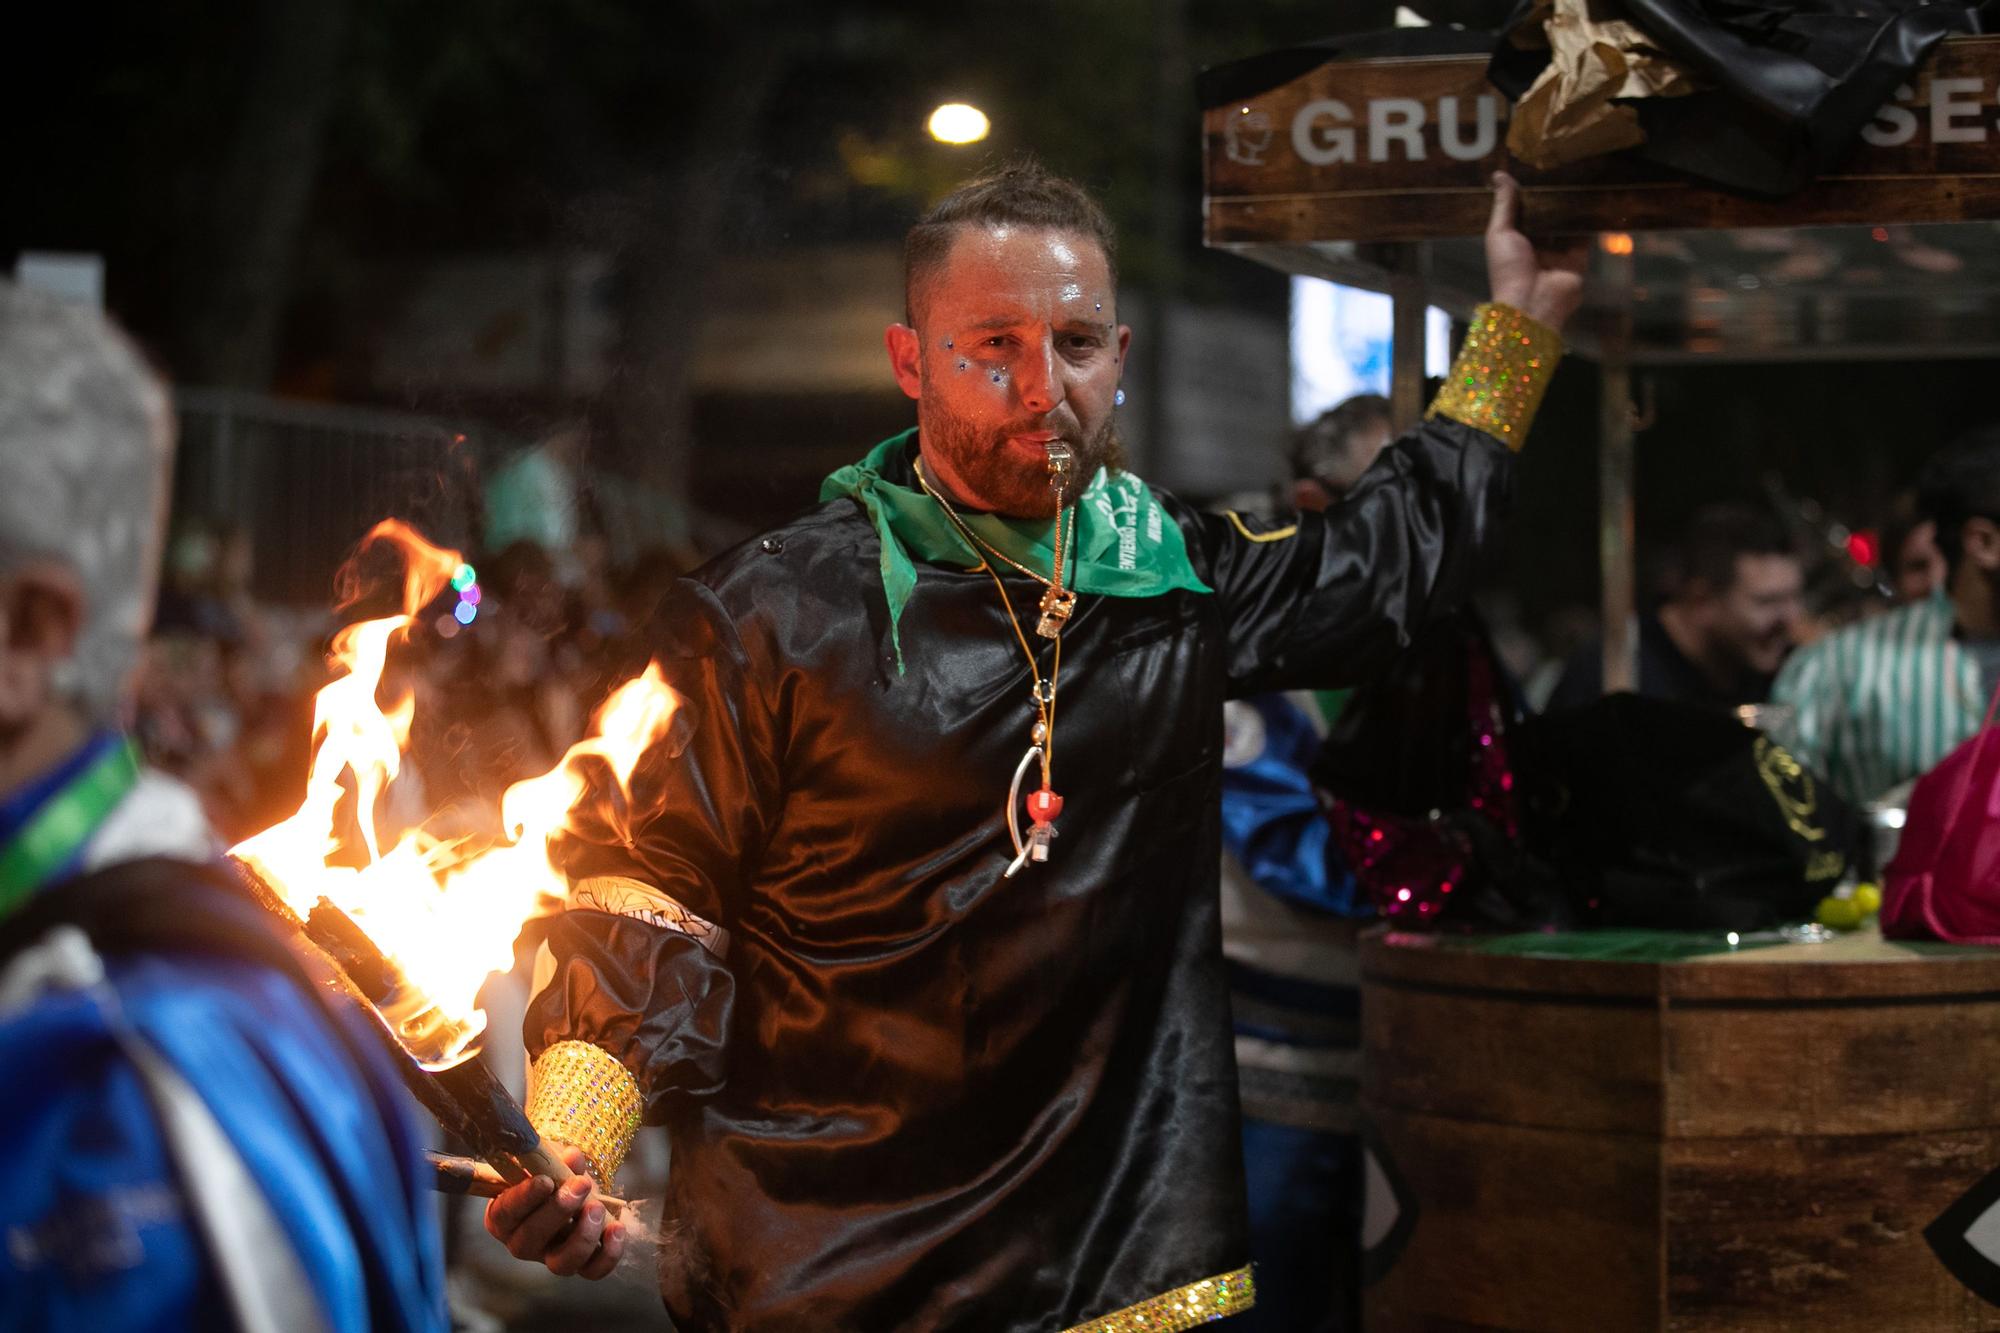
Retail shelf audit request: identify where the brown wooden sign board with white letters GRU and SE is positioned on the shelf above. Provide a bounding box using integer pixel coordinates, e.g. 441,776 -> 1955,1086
1204,36 -> 2000,248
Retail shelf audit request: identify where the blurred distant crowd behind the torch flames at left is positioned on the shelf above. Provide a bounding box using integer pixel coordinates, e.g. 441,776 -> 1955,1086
134,518 -> 694,843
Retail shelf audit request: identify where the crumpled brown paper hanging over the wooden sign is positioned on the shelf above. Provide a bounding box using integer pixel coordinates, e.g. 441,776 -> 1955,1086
1506,0 -> 1696,170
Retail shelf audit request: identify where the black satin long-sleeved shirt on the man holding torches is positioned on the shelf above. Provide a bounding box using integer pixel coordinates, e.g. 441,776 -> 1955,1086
528,422 -> 1510,1333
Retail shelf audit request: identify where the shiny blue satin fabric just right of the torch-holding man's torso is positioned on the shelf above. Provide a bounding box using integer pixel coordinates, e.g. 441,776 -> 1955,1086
1222,695 -> 1374,917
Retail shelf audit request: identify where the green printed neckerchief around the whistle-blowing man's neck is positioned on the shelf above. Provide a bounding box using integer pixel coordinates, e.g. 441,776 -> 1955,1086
820,428 -> 1212,673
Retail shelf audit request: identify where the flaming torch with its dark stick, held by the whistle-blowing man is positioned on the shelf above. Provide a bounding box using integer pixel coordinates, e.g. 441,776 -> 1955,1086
230,520 -> 676,1205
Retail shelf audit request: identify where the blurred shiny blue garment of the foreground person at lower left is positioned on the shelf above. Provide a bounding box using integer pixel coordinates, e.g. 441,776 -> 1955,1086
0,944 -> 448,1333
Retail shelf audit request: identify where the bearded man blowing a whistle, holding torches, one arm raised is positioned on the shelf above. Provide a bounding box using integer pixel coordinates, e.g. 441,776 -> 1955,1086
488,166 -> 1582,1333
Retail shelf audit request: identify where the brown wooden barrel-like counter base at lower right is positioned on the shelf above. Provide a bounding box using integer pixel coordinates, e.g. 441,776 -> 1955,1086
1362,933 -> 2000,1333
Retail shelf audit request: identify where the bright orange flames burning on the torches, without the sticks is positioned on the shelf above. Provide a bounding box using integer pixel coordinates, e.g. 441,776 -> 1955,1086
230,520 -> 678,1067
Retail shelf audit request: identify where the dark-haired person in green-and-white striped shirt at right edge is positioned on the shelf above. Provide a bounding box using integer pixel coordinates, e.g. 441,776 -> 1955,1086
1772,426 -> 2000,803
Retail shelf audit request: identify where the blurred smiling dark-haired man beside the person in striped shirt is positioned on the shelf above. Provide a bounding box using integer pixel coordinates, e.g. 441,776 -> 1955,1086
1548,504 -> 1806,711
